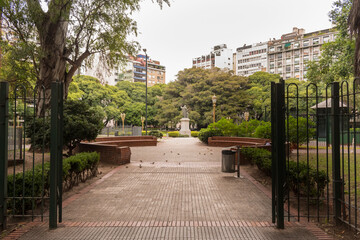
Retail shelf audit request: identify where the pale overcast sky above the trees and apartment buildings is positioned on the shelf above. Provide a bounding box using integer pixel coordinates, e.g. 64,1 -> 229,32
134,0 -> 334,83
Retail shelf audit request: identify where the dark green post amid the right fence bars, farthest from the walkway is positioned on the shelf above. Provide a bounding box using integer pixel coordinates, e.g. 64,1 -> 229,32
331,82 -> 342,219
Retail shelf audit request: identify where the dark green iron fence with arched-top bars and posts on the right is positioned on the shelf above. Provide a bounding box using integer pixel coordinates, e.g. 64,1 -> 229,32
271,79 -> 360,230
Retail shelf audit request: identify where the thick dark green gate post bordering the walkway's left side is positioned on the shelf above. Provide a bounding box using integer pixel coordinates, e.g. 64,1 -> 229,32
49,82 -> 60,229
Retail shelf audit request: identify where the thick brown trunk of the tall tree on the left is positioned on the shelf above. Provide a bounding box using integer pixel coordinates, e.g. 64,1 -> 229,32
36,18 -> 68,116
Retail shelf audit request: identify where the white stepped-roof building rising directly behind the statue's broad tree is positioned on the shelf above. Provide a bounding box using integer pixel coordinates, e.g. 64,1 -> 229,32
192,44 -> 233,70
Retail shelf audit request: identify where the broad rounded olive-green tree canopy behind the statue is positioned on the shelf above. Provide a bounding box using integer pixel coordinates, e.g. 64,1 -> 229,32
156,68 -> 250,127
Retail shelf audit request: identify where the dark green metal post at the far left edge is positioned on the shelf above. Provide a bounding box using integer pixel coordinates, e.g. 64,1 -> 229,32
0,82 -> 9,230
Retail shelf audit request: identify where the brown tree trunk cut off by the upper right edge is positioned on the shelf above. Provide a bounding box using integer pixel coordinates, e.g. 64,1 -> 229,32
348,0 -> 360,77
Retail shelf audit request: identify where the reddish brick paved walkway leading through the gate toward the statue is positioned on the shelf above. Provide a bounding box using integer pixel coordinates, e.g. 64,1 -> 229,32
9,138 -> 331,240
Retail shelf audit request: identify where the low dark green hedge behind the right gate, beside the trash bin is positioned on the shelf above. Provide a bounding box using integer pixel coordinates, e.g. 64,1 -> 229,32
241,148 -> 329,197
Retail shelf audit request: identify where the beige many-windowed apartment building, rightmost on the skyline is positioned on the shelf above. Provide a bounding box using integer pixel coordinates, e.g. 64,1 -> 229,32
267,27 -> 336,81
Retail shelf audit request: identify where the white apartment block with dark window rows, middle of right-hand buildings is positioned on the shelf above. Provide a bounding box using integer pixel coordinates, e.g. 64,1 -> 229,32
235,42 -> 268,77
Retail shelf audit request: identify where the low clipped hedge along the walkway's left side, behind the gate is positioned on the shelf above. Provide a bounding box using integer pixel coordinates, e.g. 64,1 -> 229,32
7,152 -> 100,214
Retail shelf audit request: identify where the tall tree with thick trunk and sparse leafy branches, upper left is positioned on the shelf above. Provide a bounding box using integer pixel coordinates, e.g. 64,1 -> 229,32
3,0 -> 169,114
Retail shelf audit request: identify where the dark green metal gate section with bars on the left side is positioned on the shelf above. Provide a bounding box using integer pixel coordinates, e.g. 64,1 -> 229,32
0,82 -> 63,229
